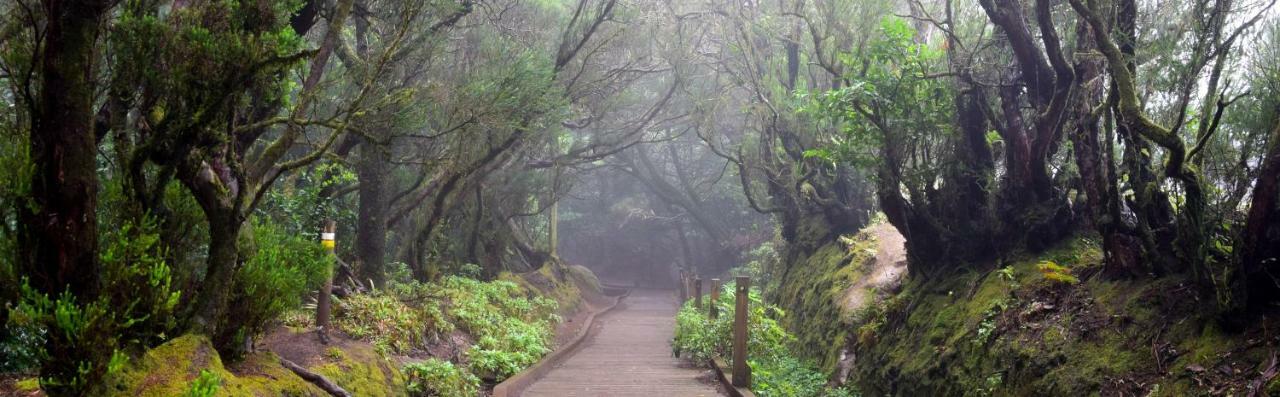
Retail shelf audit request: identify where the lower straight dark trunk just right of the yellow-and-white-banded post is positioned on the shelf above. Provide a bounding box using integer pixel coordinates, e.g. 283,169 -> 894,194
356,141 -> 390,288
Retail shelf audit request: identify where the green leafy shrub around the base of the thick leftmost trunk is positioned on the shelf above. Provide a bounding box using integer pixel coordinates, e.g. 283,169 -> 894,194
6,219 -> 180,394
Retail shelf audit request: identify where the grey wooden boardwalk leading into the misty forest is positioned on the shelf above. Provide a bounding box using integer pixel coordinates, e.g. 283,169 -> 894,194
522,289 -> 719,397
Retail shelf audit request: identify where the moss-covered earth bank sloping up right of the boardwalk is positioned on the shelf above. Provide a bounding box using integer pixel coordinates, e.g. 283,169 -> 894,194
844,237 -> 1277,396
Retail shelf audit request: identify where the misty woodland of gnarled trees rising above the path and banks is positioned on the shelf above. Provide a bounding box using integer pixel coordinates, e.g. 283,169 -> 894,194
0,0 -> 1280,394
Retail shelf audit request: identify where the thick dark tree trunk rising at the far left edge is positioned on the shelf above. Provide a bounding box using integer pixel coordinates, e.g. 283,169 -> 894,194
19,0 -> 108,296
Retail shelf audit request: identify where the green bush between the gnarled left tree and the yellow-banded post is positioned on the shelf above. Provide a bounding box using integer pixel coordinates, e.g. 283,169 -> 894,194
220,222 -> 332,355
